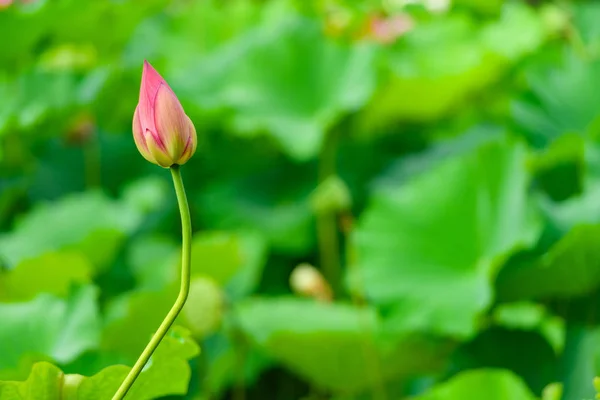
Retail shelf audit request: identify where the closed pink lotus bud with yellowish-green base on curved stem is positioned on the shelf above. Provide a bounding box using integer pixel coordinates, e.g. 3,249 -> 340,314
133,61 -> 197,168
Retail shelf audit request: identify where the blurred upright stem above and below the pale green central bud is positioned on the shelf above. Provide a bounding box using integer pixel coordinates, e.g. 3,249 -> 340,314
317,130 -> 341,295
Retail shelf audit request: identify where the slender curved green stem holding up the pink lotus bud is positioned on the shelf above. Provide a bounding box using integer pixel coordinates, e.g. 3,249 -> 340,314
113,165 -> 192,400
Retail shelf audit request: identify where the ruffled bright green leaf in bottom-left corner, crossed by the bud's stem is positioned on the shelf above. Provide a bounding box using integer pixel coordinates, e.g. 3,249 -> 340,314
0,327 -> 198,400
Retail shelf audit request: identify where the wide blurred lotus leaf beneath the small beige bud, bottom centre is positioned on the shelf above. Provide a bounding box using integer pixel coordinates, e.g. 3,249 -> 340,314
235,298 -> 446,393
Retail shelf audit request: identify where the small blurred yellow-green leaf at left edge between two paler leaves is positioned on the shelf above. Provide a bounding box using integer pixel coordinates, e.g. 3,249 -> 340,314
0,251 -> 93,301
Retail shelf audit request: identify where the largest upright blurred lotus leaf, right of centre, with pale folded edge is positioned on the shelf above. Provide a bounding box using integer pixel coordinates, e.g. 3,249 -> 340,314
351,141 -> 540,336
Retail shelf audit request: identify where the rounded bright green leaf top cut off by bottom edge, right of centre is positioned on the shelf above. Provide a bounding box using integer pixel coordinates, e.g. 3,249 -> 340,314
415,369 -> 536,400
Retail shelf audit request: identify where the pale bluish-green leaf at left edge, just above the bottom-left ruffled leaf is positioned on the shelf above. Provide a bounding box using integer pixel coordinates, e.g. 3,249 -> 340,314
0,286 -> 100,369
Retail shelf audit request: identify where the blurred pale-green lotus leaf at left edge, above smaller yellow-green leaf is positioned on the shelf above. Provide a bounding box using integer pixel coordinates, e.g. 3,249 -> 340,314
0,191 -> 142,266
